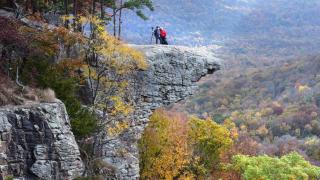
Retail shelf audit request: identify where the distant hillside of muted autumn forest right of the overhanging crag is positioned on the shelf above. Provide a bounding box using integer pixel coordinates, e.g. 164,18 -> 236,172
170,56 -> 320,170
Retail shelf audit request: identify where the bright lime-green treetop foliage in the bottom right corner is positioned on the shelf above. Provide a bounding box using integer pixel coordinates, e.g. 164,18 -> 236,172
233,152 -> 320,180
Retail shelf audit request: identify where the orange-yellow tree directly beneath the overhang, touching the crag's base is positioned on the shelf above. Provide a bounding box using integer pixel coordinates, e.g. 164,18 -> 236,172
140,111 -> 192,180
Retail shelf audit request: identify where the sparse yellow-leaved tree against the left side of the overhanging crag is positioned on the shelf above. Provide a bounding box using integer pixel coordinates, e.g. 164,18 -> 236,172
75,16 -> 148,126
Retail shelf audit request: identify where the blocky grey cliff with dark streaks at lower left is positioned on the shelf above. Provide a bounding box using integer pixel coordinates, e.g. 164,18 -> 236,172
0,102 -> 84,180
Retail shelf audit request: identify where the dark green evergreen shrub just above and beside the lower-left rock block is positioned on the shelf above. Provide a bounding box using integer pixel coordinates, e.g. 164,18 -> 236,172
22,57 -> 98,139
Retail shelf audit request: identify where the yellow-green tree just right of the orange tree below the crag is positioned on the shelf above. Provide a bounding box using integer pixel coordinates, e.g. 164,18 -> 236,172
188,117 -> 233,176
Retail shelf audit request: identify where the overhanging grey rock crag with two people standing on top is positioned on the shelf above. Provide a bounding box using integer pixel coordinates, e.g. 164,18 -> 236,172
97,45 -> 220,179
